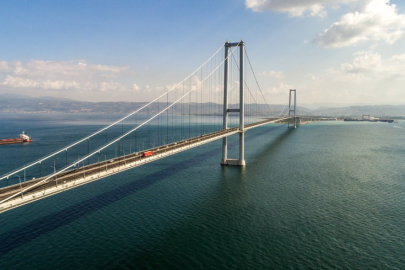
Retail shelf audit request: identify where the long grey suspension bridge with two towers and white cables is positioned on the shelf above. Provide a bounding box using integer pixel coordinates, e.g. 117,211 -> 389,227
0,41 -> 298,213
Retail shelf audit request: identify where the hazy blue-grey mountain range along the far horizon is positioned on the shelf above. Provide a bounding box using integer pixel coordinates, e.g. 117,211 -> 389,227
0,94 -> 405,118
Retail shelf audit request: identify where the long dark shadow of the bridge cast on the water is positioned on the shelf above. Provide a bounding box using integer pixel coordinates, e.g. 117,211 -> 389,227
0,125 -> 291,256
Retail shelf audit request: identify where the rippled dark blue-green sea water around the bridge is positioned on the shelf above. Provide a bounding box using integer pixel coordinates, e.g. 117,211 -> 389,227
0,114 -> 405,269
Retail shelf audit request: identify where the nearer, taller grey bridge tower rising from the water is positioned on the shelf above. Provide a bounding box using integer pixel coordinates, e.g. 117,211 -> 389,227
221,40 -> 246,166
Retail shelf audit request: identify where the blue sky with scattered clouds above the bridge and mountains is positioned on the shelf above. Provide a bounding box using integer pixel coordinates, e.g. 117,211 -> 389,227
0,0 -> 405,106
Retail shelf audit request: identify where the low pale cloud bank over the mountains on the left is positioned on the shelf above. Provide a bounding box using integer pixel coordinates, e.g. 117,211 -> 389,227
0,60 -> 131,92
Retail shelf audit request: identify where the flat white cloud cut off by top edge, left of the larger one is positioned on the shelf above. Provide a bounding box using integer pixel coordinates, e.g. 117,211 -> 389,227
245,0 -> 355,17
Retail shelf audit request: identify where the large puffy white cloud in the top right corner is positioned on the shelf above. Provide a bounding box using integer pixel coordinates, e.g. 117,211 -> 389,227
315,0 -> 405,48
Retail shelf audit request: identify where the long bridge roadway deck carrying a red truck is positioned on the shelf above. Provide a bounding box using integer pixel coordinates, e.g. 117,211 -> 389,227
0,118 -> 286,213
